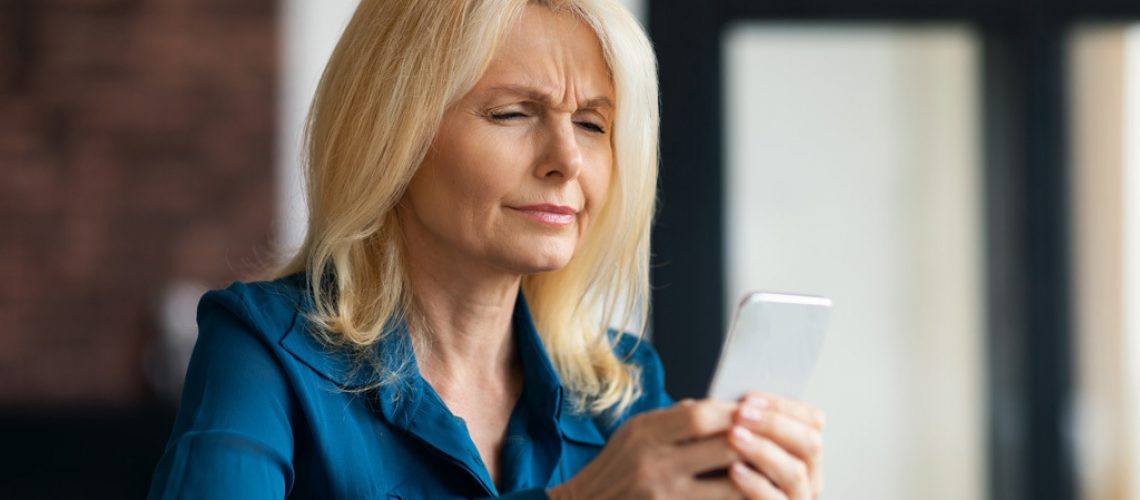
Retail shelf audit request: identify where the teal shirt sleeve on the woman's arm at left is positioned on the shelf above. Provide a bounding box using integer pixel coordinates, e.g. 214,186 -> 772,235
147,290 -> 295,499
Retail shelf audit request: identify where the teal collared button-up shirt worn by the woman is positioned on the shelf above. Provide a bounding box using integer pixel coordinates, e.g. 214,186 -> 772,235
148,274 -> 673,499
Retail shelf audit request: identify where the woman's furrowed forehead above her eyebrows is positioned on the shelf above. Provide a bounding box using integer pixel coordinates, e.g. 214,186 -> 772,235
475,6 -> 613,98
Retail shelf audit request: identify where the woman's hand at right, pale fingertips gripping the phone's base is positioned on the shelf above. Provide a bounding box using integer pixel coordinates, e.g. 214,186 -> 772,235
728,393 -> 824,500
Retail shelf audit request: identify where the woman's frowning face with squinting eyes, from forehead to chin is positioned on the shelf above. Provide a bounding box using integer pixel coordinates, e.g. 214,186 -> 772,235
399,6 -> 614,274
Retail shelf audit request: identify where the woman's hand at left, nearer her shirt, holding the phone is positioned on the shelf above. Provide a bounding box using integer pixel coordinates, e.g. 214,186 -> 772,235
547,400 -> 741,500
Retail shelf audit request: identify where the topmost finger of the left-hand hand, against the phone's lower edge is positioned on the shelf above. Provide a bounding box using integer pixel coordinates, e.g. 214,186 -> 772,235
642,400 -> 738,443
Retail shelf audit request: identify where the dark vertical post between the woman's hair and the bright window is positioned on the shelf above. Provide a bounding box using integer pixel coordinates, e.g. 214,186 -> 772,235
649,0 -> 724,397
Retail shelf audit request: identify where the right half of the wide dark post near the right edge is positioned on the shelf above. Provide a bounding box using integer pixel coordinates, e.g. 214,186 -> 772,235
1025,19 -> 1076,500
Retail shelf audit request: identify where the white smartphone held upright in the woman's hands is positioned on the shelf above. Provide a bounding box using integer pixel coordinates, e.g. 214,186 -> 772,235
708,292 -> 831,401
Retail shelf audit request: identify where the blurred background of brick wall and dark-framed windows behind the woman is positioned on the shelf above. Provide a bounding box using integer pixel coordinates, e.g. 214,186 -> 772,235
0,0 -> 1140,500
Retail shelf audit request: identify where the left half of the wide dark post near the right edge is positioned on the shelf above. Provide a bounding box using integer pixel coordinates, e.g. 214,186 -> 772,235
982,21 -> 1028,499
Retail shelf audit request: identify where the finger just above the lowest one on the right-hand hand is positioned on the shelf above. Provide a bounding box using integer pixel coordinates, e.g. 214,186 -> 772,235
728,426 -> 812,499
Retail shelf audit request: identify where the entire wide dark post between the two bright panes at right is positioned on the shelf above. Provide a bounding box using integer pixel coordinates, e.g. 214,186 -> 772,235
983,11 -> 1076,500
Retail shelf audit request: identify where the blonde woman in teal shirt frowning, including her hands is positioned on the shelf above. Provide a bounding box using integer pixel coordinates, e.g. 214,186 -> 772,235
150,0 -> 822,499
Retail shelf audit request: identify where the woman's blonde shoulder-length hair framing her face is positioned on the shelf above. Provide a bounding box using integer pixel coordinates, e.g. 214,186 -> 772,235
276,0 -> 659,415
